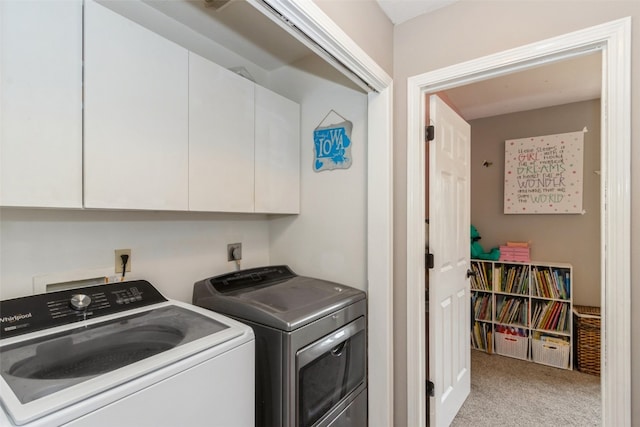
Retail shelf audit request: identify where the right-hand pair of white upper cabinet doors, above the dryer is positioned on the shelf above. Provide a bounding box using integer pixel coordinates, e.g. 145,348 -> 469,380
189,53 -> 300,213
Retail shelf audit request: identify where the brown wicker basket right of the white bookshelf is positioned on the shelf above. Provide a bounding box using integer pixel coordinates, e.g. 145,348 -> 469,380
573,305 -> 600,376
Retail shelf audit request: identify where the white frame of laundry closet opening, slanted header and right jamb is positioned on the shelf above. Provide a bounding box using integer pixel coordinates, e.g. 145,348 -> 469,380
247,0 -> 393,427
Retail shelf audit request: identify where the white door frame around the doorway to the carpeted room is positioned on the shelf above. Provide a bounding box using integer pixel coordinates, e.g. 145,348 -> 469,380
406,17 -> 631,426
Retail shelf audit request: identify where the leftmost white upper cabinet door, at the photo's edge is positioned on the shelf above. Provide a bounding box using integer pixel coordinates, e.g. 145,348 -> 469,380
0,0 -> 82,208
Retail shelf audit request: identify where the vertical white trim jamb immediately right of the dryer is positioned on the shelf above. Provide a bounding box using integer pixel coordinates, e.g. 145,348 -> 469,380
367,86 -> 393,427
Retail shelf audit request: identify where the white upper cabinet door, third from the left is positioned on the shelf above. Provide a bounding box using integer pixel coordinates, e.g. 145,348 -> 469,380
189,52 -> 255,212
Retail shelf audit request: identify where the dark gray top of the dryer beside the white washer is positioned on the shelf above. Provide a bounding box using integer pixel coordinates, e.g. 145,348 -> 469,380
194,266 -> 366,331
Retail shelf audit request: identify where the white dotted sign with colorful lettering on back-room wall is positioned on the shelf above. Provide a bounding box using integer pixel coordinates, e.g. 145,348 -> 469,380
504,131 -> 585,214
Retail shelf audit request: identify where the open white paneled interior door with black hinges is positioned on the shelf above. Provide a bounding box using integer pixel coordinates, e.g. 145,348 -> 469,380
429,95 -> 471,427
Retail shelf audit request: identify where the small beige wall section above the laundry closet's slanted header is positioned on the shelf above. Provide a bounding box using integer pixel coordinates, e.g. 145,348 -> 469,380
314,0 -> 393,76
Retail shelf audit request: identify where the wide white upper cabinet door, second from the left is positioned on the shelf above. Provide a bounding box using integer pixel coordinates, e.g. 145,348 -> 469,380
84,1 -> 188,210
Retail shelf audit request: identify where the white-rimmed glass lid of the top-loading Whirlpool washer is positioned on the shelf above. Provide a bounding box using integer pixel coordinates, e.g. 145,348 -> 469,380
0,301 -> 249,425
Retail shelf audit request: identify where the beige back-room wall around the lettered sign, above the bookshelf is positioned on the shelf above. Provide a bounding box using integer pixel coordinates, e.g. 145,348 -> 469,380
469,100 -> 600,306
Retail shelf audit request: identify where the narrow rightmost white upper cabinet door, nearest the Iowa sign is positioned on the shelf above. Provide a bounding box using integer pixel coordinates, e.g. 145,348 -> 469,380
255,86 -> 300,213
